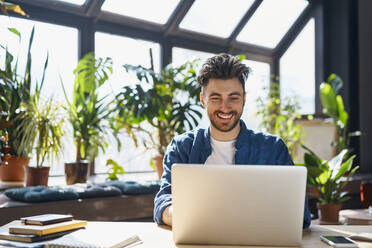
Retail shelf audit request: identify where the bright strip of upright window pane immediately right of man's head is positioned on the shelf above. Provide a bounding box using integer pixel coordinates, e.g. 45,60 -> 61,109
242,60 -> 270,130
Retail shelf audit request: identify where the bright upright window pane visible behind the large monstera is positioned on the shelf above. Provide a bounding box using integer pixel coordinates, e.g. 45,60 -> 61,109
95,32 -> 160,174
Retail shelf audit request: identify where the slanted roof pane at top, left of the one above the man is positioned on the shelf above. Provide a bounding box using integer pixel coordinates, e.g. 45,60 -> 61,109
102,0 -> 179,24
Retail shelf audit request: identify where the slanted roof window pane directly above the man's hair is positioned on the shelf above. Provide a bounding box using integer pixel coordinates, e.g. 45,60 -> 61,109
180,0 -> 253,38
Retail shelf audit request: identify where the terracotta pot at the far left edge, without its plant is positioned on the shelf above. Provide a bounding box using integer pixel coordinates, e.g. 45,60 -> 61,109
0,156 -> 29,182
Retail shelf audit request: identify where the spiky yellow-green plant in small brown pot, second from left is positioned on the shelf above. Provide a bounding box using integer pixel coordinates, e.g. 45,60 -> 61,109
17,88 -> 64,186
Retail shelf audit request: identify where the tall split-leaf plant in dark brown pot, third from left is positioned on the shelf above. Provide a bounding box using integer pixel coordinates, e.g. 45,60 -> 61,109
62,53 -> 113,184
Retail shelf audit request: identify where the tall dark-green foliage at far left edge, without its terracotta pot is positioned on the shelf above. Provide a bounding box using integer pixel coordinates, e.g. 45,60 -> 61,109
0,28 -> 48,157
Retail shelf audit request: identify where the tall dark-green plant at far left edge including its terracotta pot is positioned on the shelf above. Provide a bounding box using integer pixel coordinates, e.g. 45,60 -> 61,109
0,29 -> 38,181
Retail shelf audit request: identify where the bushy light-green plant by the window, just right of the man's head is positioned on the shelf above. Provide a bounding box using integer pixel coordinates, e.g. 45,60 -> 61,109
256,82 -> 304,158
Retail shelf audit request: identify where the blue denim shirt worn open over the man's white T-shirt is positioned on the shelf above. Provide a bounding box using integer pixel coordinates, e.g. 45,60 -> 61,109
154,120 -> 311,227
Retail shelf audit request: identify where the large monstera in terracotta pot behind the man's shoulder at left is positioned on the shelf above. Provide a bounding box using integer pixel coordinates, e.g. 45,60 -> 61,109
115,50 -> 202,178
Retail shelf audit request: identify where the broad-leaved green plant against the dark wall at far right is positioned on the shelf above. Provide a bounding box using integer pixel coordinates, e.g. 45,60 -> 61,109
320,74 -> 361,153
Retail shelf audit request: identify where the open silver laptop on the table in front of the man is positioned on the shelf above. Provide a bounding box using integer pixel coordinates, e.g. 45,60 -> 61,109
172,164 -> 307,246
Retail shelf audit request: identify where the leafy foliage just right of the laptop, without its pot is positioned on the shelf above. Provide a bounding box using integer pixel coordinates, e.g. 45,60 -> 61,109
298,146 -> 359,204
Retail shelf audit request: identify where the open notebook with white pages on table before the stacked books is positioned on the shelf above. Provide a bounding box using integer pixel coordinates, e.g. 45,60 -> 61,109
45,225 -> 142,248
